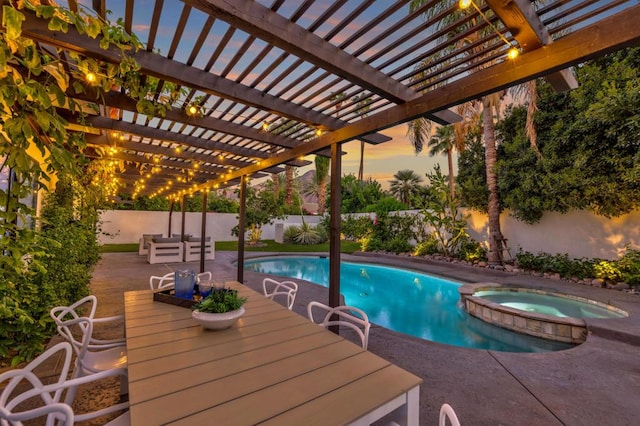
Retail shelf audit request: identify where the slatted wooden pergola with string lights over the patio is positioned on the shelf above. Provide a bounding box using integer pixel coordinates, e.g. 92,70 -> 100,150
11,0 -> 640,301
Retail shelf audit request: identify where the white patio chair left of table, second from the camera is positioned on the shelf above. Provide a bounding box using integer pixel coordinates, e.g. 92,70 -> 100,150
49,306 -> 129,403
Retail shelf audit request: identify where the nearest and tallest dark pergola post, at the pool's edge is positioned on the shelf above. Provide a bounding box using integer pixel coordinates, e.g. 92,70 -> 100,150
329,143 -> 342,307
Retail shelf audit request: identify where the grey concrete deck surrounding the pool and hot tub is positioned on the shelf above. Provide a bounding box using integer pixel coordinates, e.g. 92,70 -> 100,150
84,251 -> 640,425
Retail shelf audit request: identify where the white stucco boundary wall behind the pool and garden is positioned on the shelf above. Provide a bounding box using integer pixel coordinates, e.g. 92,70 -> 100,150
99,210 -> 640,259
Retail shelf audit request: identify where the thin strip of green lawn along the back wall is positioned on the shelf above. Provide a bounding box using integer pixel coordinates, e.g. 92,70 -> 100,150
100,240 -> 360,253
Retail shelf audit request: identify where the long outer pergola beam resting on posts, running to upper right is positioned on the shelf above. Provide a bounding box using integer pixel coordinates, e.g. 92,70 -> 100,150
195,5 -> 640,187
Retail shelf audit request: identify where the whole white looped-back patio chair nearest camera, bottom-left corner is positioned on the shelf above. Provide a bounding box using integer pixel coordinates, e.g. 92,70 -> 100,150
0,342 -> 130,426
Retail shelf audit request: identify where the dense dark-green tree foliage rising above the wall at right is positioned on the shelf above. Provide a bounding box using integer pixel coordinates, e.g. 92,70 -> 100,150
458,48 -> 640,223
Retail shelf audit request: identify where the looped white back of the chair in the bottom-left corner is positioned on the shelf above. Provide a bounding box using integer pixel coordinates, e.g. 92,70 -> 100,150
0,342 -> 74,426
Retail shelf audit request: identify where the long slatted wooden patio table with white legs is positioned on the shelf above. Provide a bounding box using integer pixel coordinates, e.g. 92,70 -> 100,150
125,282 -> 422,425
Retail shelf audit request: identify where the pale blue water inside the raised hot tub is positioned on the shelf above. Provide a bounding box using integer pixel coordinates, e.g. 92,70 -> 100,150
473,290 -> 626,318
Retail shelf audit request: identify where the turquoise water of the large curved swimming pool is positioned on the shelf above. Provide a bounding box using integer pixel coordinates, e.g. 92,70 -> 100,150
244,256 -> 572,352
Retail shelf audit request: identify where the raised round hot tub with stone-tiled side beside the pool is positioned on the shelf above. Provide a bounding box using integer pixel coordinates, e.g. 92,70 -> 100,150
459,284 -> 628,344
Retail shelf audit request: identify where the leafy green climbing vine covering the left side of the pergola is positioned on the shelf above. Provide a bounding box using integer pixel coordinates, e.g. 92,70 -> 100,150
0,1 -> 180,365
